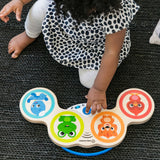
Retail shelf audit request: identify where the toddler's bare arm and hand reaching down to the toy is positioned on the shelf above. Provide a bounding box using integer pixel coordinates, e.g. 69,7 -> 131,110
86,29 -> 126,114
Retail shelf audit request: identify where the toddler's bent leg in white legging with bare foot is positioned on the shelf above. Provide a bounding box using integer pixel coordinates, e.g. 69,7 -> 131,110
8,0 -> 50,58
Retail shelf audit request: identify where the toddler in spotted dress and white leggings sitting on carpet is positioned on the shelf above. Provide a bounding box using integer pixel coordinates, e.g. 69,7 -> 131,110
0,0 -> 139,114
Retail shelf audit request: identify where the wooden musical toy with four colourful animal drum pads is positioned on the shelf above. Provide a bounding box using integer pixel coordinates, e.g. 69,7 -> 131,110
20,88 -> 154,148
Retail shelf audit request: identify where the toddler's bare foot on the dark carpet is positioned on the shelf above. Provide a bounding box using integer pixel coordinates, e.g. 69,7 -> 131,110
8,32 -> 36,58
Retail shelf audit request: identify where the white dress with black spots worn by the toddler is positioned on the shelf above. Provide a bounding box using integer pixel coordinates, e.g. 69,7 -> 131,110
42,0 -> 139,70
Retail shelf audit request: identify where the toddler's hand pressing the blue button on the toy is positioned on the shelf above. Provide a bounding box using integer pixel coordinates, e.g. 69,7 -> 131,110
86,87 -> 107,114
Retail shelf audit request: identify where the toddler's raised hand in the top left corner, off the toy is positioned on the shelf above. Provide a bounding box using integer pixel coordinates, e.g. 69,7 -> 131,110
0,0 -> 24,23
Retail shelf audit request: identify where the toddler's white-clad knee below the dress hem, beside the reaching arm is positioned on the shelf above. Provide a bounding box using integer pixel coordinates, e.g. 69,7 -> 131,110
79,69 -> 98,88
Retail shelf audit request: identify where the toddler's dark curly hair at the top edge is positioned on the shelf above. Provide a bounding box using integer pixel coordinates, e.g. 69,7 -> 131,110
55,0 -> 121,23
